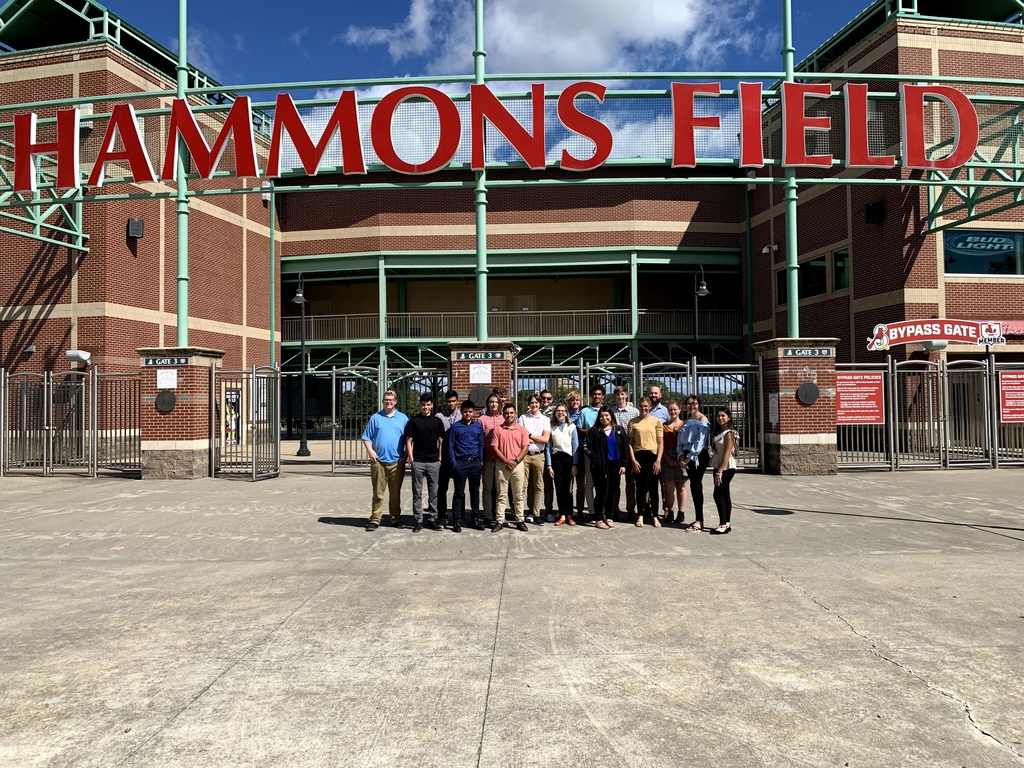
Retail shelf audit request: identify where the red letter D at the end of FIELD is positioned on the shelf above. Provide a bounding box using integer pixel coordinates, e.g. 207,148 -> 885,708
899,85 -> 981,170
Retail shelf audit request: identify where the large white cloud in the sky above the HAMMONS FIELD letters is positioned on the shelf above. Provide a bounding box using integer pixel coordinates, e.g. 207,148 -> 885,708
336,0 -> 766,75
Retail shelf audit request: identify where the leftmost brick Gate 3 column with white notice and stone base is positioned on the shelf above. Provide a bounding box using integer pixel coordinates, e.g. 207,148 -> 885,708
137,347 -> 224,480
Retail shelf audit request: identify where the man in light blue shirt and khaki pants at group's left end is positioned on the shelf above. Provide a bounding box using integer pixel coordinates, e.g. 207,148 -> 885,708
362,389 -> 409,530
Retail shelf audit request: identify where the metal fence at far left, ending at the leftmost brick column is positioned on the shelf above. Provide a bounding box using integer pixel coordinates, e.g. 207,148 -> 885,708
0,367 -> 141,477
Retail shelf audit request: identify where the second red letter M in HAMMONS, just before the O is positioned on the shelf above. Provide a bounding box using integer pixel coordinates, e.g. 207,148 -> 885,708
266,91 -> 367,176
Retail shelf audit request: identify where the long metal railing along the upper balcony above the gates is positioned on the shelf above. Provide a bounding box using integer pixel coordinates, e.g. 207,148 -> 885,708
282,309 -> 742,341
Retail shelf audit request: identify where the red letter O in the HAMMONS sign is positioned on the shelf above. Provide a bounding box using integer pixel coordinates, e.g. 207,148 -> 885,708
370,85 -> 462,174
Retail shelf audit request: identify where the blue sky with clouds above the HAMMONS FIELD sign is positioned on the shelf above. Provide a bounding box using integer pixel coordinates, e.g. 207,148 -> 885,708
94,0 -> 868,92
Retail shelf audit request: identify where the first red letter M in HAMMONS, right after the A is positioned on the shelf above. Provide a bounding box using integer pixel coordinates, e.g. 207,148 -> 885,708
161,96 -> 259,179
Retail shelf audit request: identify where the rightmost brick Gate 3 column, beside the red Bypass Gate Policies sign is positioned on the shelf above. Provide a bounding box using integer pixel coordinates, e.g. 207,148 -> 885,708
754,339 -> 839,475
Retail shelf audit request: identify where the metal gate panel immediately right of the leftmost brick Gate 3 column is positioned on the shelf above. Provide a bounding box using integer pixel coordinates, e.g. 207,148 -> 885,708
210,366 -> 281,480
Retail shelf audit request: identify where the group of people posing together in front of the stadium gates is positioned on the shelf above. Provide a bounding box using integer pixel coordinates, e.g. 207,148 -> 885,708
361,385 -> 738,535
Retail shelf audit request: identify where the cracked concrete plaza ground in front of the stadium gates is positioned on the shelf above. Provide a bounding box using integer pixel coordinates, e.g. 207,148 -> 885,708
0,450 -> 1024,768
